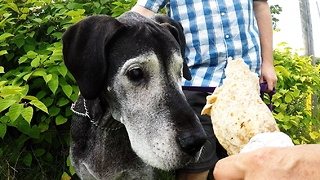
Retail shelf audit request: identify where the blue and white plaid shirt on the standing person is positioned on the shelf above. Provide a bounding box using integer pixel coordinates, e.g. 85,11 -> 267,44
137,0 -> 261,87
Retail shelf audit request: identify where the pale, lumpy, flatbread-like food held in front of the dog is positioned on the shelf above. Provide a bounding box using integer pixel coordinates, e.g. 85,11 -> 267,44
202,59 -> 292,155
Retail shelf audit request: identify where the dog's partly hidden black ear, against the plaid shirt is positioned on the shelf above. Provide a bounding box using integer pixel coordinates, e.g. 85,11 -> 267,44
152,14 -> 192,80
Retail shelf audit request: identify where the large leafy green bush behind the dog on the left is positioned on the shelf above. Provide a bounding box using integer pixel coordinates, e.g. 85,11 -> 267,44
0,0 -> 134,179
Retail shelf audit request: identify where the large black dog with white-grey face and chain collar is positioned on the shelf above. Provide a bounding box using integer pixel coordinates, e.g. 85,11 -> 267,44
62,12 -> 206,180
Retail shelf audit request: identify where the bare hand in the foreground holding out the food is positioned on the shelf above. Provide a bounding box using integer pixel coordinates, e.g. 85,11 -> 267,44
214,144 -> 320,180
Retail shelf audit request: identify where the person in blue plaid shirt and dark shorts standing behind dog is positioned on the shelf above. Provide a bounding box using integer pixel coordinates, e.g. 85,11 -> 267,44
131,0 -> 277,180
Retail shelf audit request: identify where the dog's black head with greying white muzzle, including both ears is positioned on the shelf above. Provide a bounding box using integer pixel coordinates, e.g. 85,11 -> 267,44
63,12 -> 206,169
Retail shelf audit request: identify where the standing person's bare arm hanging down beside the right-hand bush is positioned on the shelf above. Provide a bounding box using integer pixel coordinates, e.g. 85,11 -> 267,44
253,0 -> 277,91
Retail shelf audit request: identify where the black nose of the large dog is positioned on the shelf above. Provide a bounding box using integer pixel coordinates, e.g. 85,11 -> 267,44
177,132 -> 207,156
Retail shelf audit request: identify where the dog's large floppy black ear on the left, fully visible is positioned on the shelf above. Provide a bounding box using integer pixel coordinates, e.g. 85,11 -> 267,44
62,16 -> 124,100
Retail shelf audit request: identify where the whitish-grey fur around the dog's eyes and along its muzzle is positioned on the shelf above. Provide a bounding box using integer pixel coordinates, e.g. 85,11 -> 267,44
113,53 -> 190,169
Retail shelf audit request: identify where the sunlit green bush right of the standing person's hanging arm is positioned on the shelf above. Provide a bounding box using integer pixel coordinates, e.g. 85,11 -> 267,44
273,44 -> 320,144
